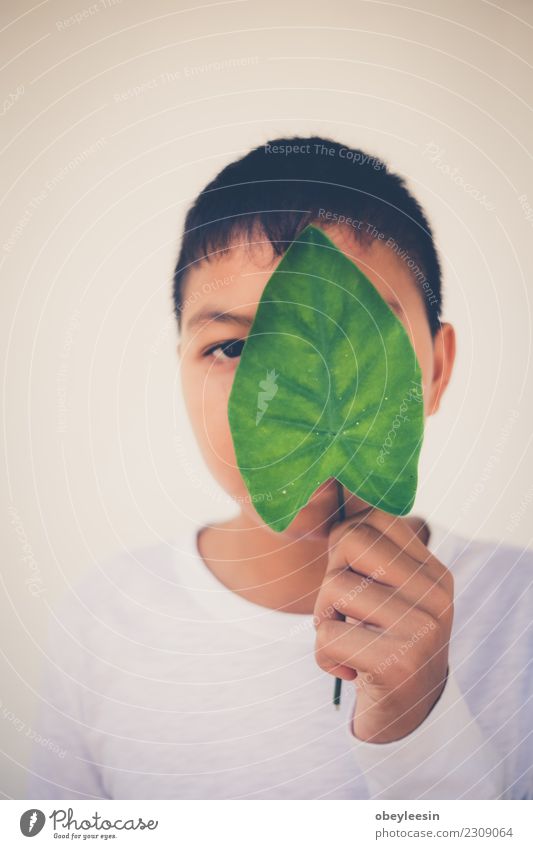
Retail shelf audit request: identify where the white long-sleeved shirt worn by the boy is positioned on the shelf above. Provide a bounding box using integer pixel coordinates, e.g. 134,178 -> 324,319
28,522 -> 533,799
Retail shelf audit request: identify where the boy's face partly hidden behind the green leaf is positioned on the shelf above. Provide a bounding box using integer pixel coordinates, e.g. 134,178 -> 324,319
178,226 -> 454,538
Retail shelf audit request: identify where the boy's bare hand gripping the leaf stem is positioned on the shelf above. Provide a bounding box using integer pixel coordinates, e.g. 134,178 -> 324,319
314,509 -> 453,743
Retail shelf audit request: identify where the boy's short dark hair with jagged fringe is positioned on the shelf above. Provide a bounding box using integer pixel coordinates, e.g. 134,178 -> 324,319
173,136 -> 441,336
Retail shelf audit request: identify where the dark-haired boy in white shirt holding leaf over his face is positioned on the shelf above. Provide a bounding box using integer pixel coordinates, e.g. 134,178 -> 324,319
29,138 -> 533,799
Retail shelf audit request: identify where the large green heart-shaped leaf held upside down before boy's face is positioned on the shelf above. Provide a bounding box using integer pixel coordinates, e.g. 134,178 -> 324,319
228,226 -> 424,532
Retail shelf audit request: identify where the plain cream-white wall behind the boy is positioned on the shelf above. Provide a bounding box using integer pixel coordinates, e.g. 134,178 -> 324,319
0,0 -> 533,798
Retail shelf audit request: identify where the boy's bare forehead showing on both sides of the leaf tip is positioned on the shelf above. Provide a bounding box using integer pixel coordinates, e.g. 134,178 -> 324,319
181,227 -> 422,332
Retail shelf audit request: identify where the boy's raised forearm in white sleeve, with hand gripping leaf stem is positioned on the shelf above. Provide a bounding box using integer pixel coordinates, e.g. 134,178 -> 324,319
315,510 -> 504,798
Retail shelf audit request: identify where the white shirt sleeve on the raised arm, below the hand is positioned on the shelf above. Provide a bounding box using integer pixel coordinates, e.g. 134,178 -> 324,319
349,668 -> 504,799
